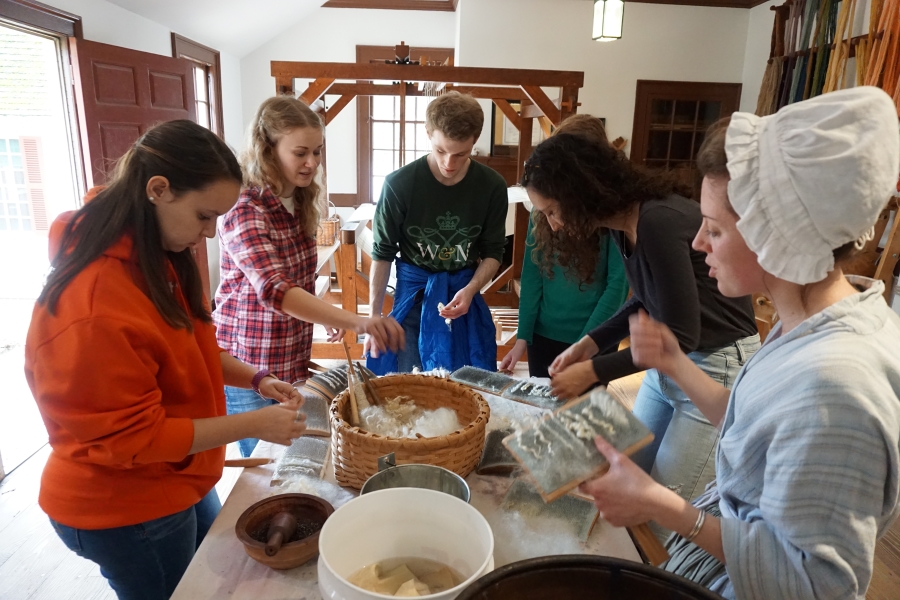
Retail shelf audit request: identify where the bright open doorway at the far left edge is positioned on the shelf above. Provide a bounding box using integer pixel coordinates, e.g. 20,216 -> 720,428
0,23 -> 81,473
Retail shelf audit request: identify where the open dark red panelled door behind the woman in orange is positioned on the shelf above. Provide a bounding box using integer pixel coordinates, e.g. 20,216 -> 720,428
69,38 -> 209,291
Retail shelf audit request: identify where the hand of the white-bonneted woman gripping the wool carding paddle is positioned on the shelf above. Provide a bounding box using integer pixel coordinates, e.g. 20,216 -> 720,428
578,436 -> 674,527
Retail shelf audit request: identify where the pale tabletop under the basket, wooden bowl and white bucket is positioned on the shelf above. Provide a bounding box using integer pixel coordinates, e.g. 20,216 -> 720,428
172,386 -> 640,600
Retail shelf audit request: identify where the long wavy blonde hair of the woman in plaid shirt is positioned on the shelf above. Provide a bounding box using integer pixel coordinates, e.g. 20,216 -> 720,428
241,96 -> 325,236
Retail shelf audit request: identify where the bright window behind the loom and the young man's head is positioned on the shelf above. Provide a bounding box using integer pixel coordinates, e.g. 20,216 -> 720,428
356,46 -> 453,204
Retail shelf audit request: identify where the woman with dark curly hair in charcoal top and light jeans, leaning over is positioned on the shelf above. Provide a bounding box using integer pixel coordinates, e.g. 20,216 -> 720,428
522,126 -> 759,516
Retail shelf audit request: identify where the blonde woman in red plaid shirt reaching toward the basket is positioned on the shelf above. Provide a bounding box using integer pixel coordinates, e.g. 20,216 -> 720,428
213,96 -> 403,456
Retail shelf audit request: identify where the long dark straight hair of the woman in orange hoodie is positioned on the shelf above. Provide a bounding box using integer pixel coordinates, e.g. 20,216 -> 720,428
38,120 -> 241,330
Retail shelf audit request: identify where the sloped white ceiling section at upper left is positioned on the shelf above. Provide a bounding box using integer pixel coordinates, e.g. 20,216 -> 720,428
108,0 -> 326,58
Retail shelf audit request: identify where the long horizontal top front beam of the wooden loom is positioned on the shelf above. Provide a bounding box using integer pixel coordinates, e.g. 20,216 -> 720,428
271,60 -> 584,87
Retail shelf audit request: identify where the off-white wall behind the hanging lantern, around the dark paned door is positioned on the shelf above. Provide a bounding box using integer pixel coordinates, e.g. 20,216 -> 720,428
456,0 -> 749,155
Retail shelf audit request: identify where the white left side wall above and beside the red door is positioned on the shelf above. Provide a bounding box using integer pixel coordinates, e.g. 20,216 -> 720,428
45,0 -> 242,147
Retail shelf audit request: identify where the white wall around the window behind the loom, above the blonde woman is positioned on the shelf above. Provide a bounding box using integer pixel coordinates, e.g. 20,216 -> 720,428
241,8 -> 456,194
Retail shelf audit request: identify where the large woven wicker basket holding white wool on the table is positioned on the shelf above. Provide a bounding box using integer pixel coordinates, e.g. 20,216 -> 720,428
331,375 -> 491,490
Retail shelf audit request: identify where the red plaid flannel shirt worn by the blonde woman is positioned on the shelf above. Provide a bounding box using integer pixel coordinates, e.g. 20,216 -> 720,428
213,187 -> 317,382
